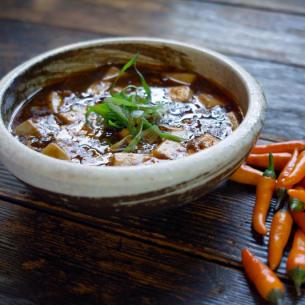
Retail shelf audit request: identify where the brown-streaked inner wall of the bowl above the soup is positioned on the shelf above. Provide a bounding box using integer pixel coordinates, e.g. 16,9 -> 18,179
1,41 -> 249,127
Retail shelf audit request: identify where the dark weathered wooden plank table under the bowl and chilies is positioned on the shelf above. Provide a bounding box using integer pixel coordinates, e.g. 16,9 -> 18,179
0,0 -> 305,305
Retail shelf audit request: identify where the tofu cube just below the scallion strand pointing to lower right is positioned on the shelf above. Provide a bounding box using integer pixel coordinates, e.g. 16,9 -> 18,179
151,140 -> 187,160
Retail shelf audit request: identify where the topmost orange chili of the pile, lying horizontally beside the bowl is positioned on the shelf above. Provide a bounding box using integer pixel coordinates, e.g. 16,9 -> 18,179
251,141 -> 305,154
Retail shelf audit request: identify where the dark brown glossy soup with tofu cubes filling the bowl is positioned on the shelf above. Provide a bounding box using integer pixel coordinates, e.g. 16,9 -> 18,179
9,59 -> 242,166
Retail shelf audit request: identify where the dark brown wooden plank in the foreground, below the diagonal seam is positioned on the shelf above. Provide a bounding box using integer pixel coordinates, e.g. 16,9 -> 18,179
0,197 -> 296,305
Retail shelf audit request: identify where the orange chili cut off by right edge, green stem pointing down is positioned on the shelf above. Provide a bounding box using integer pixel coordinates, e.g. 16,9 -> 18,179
286,229 -> 305,296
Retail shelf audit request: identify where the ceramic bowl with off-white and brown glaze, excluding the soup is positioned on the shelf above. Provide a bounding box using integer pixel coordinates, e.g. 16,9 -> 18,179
0,38 -> 267,216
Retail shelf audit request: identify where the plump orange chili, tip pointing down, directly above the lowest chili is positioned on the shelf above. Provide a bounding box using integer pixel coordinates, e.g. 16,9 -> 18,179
269,204 -> 293,270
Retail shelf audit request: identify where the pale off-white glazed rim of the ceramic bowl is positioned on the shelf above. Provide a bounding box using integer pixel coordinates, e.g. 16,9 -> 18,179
0,37 -> 266,197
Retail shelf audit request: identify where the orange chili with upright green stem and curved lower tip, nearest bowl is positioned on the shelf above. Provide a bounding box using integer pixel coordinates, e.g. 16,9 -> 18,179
252,153 -> 276,235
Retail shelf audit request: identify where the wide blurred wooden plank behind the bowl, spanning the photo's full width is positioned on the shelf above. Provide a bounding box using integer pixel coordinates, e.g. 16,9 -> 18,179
0,0 -> 305,66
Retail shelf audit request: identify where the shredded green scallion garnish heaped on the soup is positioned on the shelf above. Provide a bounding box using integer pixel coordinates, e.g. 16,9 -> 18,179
86,53 -> 184,152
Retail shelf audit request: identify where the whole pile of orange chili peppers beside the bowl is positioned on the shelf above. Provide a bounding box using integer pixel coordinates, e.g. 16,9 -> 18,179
230,141 -> 305,304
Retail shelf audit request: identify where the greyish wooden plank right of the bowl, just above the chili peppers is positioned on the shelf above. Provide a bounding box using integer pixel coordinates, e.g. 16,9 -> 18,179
231,56 -> 305,141
